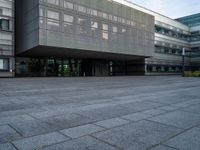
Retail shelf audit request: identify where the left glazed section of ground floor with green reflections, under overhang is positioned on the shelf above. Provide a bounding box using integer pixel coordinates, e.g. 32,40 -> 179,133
16,58 -> 82,77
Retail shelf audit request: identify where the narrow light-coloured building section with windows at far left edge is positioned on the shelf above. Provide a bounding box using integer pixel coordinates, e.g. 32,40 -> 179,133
0,0 -> 15,77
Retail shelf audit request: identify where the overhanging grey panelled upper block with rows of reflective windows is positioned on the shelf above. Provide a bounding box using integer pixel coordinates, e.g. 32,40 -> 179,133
16,0 -> 155,59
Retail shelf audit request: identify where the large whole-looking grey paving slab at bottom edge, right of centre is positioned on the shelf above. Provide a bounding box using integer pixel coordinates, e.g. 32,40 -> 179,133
93,121 -> 181,150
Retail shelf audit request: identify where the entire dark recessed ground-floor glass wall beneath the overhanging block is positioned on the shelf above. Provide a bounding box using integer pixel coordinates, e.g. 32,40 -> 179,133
16,57 -> 145,77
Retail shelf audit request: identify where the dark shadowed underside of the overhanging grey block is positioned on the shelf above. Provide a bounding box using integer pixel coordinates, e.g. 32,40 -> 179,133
17,46 -> 149,61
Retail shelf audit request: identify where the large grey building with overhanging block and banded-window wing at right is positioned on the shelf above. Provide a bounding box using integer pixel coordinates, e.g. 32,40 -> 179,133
0,0 -> 200,76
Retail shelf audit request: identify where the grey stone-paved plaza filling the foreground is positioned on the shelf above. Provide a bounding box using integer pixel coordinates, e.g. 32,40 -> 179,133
0,76 -> 200,150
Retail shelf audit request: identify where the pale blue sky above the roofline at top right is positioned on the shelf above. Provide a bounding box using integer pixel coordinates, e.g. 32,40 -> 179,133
128,0 -> 200,19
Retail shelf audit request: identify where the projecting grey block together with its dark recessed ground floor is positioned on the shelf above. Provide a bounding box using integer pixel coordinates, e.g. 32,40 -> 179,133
16,0 -> 154,76
